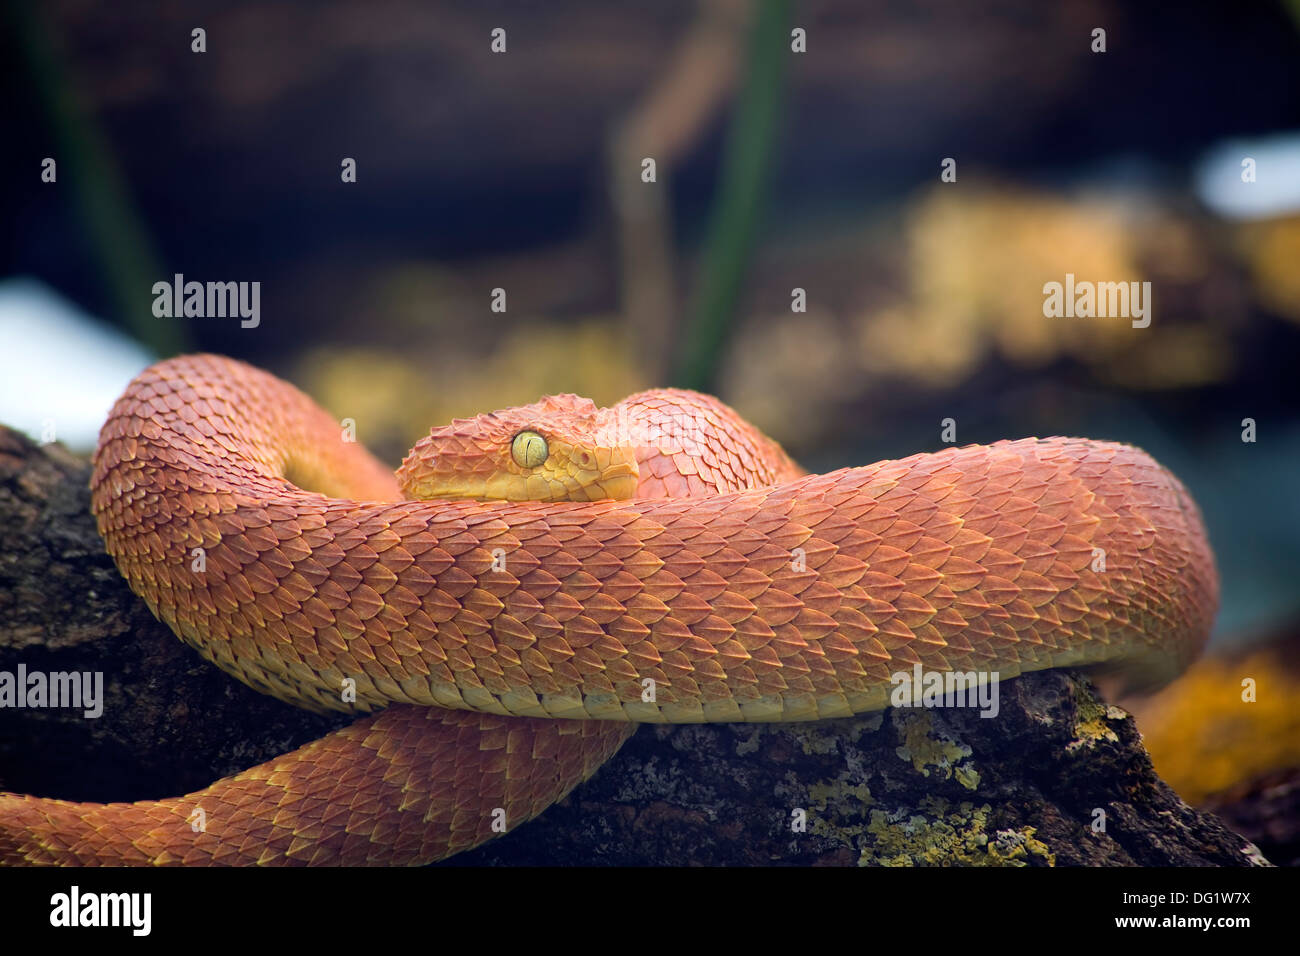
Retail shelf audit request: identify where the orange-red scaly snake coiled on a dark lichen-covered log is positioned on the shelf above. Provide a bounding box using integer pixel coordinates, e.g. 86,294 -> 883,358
0,355 -> 1218,865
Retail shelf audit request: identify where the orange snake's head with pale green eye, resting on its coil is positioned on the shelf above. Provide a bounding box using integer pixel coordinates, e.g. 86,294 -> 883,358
397,395 -> 638,501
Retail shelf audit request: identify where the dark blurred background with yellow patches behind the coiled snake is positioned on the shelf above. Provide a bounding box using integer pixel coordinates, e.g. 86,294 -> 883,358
0,0 -> 1300,858
